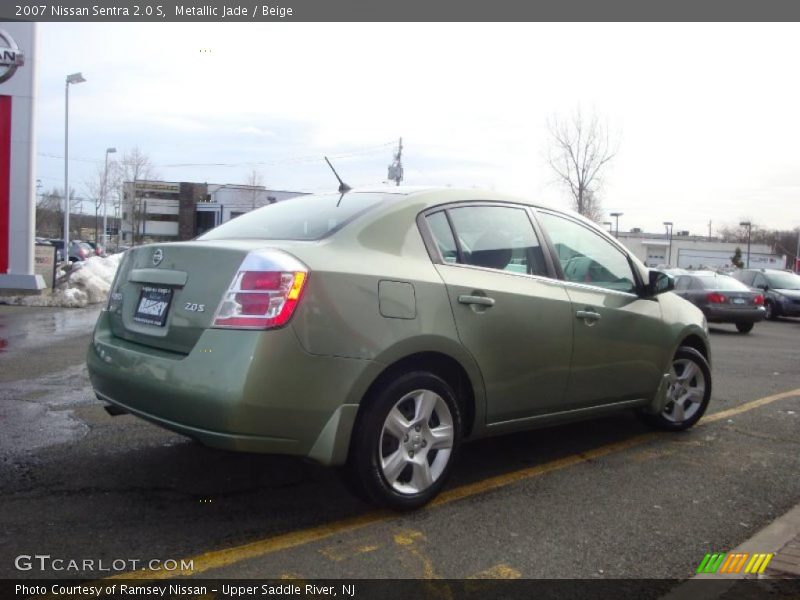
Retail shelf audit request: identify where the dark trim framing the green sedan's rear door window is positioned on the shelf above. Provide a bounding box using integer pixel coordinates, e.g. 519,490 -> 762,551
417,200 -> 560,281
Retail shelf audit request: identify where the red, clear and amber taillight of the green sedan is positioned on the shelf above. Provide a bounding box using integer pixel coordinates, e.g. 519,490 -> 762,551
214,252 -> 308,329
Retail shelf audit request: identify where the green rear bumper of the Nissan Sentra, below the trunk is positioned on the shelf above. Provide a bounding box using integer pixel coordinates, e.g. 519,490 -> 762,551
87,313 -> 380,464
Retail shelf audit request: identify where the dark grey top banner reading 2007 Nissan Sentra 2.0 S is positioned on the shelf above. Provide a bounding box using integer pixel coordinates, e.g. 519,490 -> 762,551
0,0 -> 800,23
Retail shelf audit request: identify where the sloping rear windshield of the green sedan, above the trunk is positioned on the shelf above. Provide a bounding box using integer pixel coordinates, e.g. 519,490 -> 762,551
197,192 -> 386,240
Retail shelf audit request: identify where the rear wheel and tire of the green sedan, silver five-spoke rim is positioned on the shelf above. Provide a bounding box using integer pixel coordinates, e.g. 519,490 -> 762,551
345,371 -> 462,510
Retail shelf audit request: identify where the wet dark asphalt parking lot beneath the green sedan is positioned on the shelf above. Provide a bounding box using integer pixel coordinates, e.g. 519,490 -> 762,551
0,307 -> 800,579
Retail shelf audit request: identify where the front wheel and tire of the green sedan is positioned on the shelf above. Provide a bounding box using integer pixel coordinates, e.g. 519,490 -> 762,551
639,346 -> 711,431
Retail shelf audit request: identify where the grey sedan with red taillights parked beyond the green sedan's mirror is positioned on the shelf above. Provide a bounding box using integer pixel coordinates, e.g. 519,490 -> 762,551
675,271 -> 766,333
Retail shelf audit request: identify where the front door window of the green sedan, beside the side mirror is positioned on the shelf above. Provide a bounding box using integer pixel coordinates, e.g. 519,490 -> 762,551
538,212 -> 636,293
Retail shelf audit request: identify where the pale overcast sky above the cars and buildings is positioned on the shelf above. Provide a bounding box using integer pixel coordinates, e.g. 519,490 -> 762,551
37,23 -> 800,235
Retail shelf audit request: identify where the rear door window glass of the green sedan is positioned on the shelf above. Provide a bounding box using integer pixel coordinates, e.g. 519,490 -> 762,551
429,206 -> 548,276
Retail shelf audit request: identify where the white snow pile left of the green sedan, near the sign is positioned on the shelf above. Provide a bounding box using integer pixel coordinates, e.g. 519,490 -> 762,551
0,253 -> 122,308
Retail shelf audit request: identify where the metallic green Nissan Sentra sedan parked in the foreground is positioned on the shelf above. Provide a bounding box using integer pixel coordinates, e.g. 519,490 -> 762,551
88,188 -> 711,509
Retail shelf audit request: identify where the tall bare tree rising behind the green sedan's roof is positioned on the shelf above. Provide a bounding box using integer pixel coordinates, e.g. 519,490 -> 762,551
548,109 -> 616,221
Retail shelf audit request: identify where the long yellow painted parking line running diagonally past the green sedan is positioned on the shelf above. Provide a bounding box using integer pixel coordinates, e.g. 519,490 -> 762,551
103,388 -> 800,579
